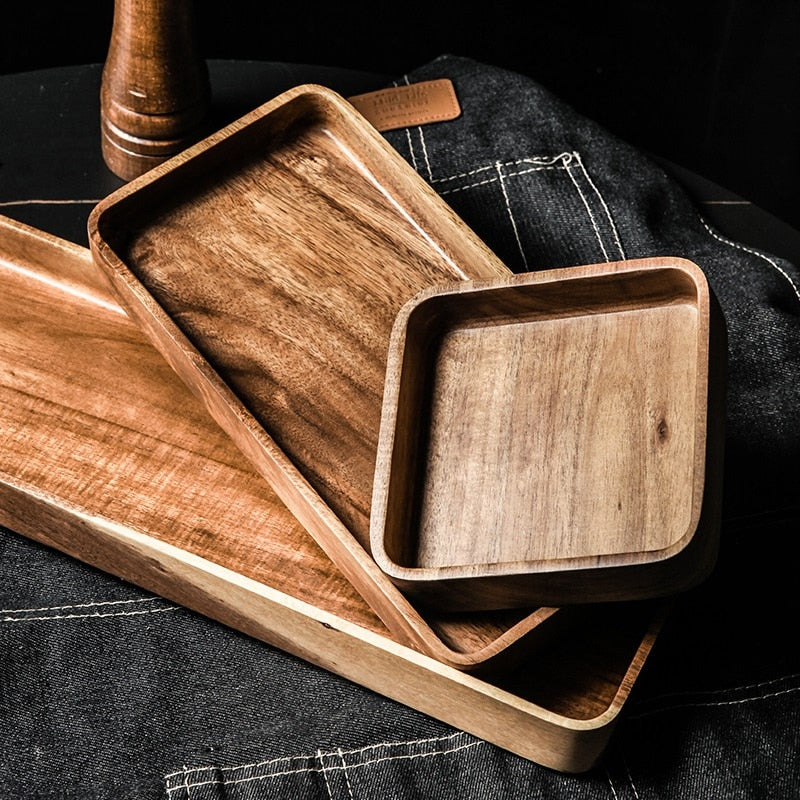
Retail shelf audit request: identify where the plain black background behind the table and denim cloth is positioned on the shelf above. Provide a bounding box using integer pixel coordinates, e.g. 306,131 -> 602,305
0,0 -> 800,228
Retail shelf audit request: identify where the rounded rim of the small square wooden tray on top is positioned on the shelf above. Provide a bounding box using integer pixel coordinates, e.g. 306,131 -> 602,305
370,256 -> 724,607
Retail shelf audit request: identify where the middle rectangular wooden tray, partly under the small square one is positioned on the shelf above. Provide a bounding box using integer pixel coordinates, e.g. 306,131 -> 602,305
89,81 -> 524,654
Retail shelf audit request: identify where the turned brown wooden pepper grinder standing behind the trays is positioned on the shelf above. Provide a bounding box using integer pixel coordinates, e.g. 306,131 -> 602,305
100,0 -> 211,180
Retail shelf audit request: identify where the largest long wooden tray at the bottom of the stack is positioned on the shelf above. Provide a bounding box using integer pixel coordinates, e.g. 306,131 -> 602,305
0,218 -> 659,772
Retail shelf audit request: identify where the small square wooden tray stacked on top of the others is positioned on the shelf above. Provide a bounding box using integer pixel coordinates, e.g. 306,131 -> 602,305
372,258 -> 725,609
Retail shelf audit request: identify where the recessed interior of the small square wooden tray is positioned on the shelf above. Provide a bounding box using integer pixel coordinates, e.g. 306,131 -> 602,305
387,275 -> 698,569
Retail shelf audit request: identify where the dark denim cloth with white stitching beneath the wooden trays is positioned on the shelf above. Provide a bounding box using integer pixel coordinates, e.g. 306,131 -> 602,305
0,57 -> 800,800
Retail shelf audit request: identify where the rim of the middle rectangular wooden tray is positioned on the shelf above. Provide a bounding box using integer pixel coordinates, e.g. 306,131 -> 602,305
87,83 -> 558,670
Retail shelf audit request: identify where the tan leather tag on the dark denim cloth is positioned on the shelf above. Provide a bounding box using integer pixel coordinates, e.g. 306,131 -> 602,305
348,78 -> 461,131
